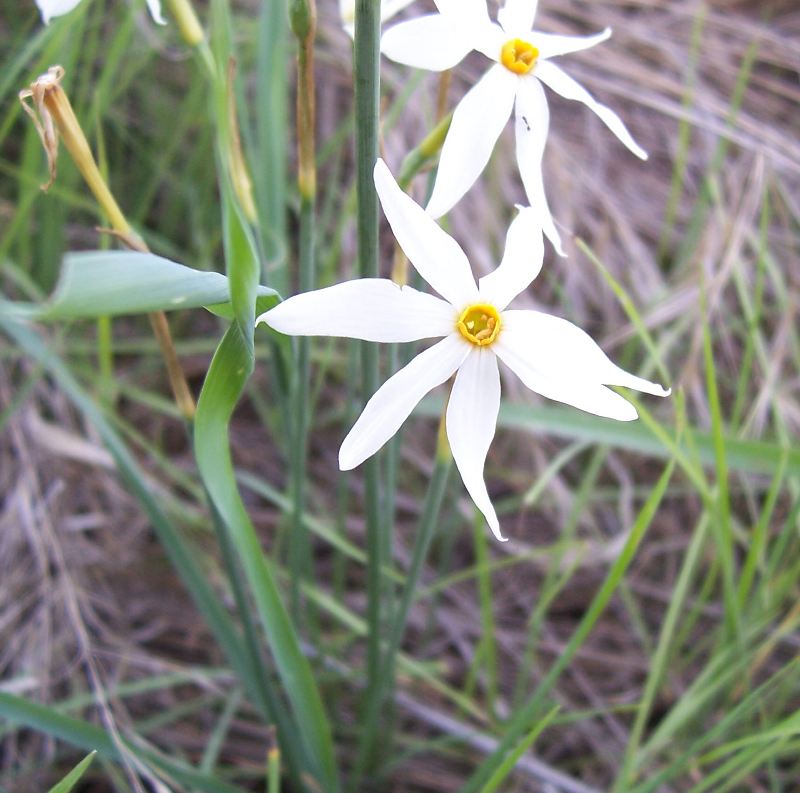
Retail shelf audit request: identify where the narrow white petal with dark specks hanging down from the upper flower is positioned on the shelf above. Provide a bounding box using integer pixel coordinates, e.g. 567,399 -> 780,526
514,77 -> 566,256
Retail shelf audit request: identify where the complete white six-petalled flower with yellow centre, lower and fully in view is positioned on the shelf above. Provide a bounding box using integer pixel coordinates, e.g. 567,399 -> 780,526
257,160 -> 669,540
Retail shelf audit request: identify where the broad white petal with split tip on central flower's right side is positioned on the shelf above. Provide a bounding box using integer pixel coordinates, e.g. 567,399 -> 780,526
492,311 -> 670,421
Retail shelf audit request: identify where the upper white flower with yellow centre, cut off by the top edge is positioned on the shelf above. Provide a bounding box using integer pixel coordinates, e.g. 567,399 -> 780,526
381,0 -> 647,255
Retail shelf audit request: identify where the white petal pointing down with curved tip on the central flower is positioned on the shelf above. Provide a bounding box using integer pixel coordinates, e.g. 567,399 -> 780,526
447,347 -> 505,540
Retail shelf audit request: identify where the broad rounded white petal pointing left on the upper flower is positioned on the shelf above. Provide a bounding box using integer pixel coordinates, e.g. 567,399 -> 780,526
381,14 -> 472,72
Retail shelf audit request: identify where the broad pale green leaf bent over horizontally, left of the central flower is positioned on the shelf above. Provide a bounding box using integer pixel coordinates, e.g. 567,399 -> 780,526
0,251 -> 278,321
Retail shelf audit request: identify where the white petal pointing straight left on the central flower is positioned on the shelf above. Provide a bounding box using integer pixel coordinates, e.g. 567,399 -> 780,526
256,278 -> 456,342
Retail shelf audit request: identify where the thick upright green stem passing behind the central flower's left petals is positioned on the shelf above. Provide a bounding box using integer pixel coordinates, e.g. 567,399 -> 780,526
354,0 -> 383,784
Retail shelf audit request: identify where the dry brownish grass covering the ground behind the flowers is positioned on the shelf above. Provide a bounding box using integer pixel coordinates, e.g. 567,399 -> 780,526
0,0 -> 800,793
